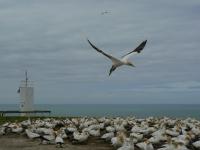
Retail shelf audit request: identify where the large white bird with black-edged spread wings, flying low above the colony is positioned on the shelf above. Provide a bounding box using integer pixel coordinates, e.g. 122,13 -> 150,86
87,39 -> 147,76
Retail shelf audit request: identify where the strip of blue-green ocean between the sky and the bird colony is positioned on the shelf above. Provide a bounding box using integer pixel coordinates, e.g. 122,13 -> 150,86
0,104 -> 200,119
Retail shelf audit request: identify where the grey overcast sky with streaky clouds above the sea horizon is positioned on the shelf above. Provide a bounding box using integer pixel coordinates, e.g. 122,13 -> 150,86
0,0 -> 200,104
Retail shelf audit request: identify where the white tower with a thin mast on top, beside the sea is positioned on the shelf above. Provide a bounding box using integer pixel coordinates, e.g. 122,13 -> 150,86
18,71 -> 33,116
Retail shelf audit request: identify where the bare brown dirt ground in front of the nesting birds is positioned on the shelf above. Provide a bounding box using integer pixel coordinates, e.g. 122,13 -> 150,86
0,135 -> 114,150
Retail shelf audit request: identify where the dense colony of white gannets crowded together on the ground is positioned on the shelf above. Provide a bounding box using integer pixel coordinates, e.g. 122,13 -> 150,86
0,117 -> 200,150
